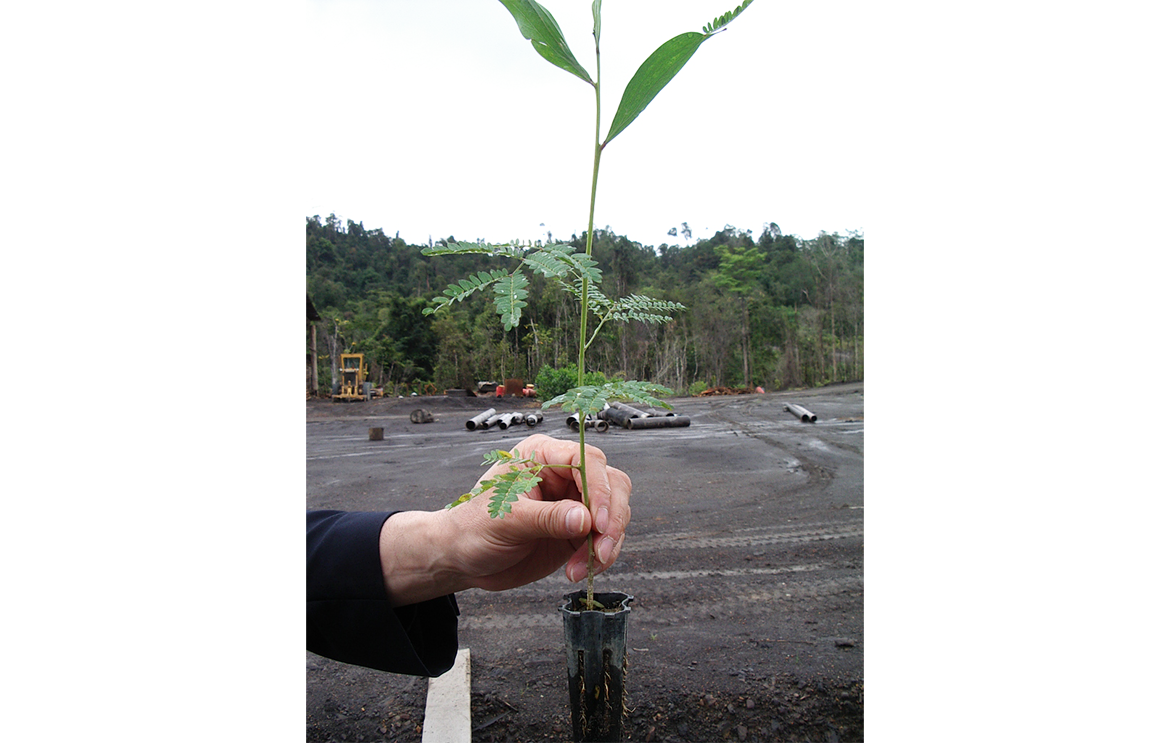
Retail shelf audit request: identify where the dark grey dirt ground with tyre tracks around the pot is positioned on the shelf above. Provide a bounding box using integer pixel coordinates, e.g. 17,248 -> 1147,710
305,383 -> 865,743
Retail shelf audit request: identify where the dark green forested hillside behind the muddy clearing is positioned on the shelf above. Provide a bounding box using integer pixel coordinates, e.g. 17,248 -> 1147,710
305,214 -> 865,393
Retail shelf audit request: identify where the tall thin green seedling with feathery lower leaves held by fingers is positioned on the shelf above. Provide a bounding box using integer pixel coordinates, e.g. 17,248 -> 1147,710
422,0 -> 752,608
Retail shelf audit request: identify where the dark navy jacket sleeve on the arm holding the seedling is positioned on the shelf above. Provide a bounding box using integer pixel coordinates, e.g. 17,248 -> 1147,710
307,511 -> 459,676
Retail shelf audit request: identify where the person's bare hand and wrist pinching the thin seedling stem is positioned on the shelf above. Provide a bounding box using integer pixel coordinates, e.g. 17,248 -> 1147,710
383,434 -> 631,603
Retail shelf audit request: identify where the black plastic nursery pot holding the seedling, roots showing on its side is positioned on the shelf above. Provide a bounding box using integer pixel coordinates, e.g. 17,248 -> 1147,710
560,591 -> 633,743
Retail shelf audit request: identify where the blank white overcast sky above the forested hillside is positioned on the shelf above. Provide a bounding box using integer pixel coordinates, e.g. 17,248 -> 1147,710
304,0 -> 866,246
